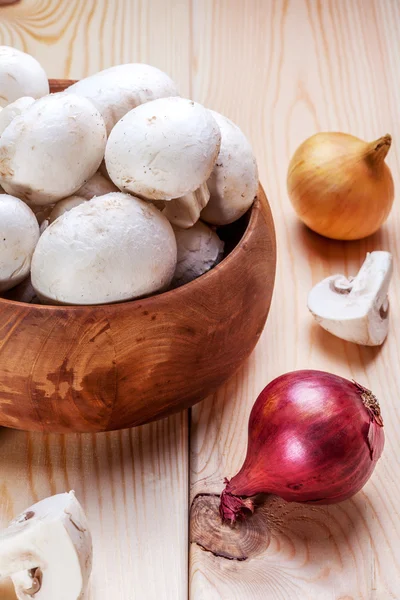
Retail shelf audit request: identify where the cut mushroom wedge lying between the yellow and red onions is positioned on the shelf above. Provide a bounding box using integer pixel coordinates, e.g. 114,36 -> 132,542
308,251 -> 393,346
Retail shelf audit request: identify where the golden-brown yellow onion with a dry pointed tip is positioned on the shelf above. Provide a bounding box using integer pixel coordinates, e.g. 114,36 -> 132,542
287,132 -> 394,240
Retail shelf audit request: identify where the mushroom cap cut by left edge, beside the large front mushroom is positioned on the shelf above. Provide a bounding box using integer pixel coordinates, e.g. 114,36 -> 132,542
0,194 -> 39,292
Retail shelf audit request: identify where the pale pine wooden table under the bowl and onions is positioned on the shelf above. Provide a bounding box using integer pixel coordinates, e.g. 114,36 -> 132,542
0,0 -> 400,600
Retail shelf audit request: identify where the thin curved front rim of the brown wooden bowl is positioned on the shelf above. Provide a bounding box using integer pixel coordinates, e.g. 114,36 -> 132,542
0,190 -> 266,312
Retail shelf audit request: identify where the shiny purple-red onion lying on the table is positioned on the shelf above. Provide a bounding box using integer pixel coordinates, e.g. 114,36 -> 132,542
220,371 -> 385,522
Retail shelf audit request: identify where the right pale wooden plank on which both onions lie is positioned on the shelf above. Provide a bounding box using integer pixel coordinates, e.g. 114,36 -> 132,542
190,0 -> 400,600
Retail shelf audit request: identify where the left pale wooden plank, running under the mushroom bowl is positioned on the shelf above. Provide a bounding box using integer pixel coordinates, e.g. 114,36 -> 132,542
0,0 -> 190,600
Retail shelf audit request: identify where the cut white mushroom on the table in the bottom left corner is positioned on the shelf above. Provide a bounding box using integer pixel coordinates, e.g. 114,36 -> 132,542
0,492 -> 92,600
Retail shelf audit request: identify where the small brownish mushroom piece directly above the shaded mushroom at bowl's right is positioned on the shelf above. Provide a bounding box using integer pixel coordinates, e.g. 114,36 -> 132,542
163,183 -> 210,229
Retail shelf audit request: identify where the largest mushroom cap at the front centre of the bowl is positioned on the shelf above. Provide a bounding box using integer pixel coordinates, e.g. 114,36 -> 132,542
32,192 -> 176,304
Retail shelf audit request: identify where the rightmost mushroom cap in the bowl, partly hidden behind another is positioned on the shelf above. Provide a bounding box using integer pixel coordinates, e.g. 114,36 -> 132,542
201,110 -> 258,225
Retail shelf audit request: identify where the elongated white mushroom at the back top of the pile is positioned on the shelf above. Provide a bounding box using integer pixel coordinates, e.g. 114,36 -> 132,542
68,63 -> 178,134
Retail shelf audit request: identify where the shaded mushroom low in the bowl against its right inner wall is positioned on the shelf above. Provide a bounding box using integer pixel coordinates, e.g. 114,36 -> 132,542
172,221 -> 224,287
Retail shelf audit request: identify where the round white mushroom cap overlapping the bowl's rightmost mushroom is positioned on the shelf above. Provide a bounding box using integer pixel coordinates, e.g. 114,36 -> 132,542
105,97 -> 221,200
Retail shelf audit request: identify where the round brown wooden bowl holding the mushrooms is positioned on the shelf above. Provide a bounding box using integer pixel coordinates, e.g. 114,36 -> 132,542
0,82 -> 276,432
